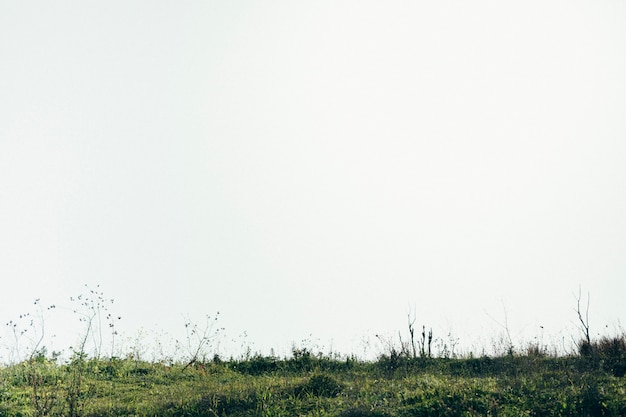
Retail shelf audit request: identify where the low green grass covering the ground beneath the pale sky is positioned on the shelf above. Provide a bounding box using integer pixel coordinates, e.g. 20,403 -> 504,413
0,351 -> 626,417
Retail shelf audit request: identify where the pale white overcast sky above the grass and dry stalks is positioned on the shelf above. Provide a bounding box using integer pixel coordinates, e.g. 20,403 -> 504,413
0,0 -> 626,355
